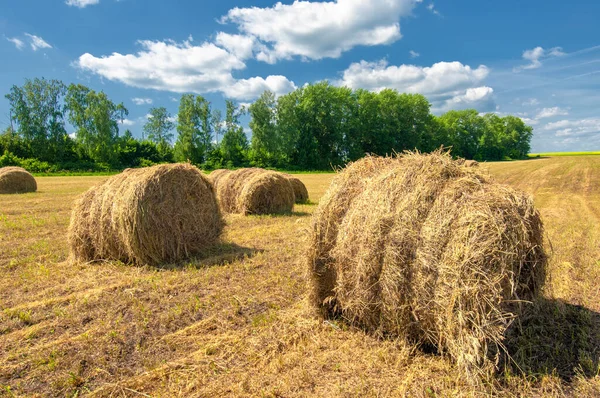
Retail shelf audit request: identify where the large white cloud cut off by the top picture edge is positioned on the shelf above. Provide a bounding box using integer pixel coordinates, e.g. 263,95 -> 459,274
221,0 -> 419,63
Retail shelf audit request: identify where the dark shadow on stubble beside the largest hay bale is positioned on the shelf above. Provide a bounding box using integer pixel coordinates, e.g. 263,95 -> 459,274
505,298 -> 600,381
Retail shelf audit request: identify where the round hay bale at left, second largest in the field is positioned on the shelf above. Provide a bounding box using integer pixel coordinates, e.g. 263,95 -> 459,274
68,164 -> 223,266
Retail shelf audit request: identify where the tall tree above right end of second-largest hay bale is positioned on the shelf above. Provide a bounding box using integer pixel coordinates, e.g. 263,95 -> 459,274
175,94 -> 212,164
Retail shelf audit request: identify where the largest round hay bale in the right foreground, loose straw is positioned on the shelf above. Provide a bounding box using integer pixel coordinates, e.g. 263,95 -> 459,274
307,151 -> 546,375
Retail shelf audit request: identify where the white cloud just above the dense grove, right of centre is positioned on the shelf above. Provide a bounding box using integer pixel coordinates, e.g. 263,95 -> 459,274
337,60 -> 494,111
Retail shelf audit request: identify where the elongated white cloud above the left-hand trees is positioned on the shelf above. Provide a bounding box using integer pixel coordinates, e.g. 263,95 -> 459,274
76,38 -> 295,99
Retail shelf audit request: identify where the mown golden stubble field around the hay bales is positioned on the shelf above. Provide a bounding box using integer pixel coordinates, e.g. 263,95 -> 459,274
0,156 -> 600,397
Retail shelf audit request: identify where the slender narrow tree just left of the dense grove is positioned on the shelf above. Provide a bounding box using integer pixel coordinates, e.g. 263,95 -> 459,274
219,100 -> 248,167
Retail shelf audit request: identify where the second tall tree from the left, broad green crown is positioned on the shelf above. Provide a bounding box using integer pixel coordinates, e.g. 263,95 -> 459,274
66,84 -> 129,165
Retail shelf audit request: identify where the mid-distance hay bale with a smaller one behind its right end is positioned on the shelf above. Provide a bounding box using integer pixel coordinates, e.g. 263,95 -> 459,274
216,168 -> 295,215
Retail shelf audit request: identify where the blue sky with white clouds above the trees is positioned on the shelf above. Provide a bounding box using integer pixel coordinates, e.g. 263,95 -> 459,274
0,0 -> 600,153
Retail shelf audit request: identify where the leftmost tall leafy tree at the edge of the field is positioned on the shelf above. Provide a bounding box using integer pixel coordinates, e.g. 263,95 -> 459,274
5,78 -> 67,162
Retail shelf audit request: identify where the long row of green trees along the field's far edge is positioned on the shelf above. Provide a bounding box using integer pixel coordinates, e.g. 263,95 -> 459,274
0,78 -> 532,172
